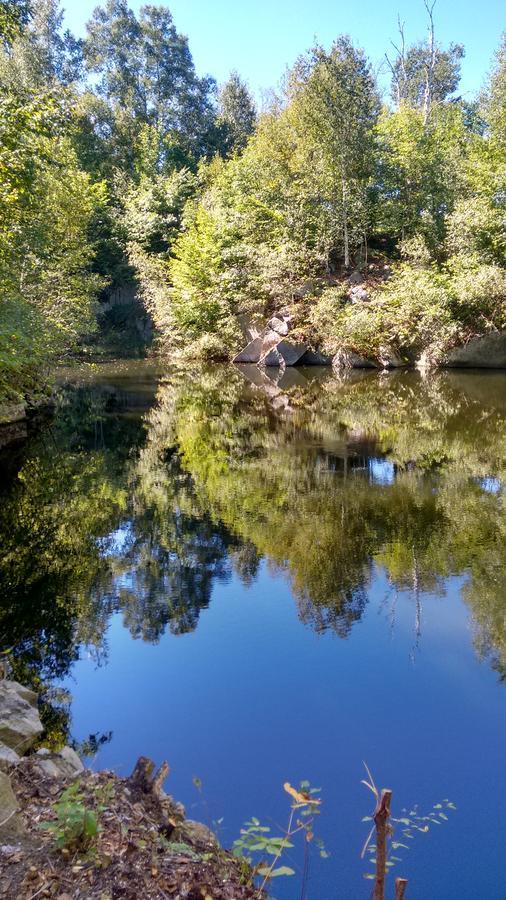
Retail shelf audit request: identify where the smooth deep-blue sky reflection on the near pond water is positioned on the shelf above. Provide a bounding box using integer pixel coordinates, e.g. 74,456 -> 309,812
62,562 -> 506,900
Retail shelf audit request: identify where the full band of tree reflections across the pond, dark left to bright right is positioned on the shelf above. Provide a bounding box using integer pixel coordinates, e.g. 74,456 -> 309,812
0,369 -> 506,731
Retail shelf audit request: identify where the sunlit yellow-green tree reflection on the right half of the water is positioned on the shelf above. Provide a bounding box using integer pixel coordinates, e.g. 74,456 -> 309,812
149,372 -> 506,673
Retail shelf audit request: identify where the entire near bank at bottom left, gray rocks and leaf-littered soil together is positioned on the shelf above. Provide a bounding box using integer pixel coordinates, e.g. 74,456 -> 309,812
0,679 -> 264,900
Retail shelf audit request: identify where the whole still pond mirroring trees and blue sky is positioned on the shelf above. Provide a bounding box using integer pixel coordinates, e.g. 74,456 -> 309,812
0,361 -> 506,900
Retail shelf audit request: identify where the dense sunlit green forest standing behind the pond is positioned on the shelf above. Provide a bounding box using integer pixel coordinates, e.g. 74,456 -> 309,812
0,0 -> 506,399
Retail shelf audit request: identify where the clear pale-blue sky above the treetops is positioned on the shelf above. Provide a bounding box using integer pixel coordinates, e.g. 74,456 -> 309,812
62,0 -> 506,97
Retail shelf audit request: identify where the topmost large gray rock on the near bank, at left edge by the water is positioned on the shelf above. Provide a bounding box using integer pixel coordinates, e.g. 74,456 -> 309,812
0,680 -> 43,753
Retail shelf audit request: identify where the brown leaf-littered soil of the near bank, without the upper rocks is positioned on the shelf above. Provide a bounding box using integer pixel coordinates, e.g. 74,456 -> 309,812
0,757 -> 265,900
